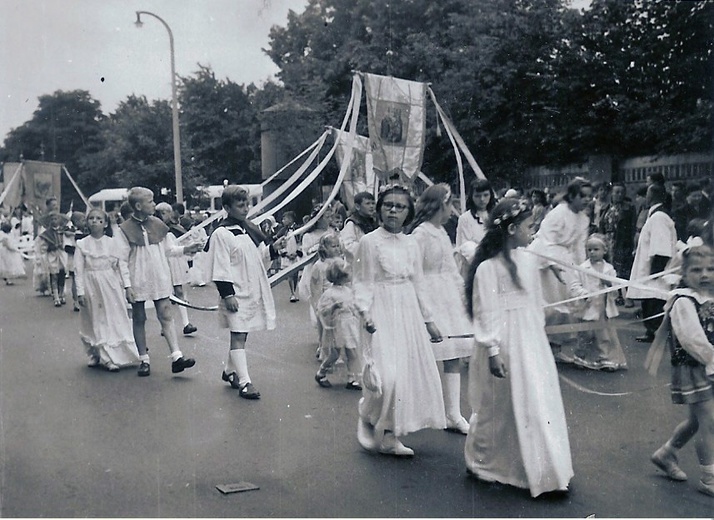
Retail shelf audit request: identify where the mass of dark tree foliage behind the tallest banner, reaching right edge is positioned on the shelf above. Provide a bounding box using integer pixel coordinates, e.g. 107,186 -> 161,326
266,0 -> 714,185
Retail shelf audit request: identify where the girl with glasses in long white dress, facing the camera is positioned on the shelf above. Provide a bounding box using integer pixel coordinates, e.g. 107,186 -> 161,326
353,185 -> 446,456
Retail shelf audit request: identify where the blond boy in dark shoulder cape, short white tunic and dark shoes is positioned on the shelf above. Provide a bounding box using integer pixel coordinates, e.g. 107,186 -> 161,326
115,187 -> 201,377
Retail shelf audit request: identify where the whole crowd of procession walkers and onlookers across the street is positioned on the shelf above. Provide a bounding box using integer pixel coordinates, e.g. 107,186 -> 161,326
0,174 -> 714,497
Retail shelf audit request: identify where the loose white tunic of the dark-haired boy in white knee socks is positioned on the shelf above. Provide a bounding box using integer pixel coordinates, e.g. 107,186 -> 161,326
208,226 -> 275,332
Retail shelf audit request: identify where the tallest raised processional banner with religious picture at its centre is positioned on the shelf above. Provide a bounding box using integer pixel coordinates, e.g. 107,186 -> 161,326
364,74 -> 426,184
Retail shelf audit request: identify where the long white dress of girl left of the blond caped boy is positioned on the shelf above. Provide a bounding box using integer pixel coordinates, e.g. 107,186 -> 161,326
74,236 -> 139,367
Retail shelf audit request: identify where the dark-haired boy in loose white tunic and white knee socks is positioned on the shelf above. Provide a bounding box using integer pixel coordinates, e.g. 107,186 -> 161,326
208,185 -> 275,399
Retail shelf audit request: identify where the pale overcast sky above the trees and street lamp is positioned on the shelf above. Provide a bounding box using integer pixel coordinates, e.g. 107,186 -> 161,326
0,0 -> 307,143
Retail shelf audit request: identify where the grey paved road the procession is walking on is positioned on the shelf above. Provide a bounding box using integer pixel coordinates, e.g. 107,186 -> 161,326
0,280 -> 714,517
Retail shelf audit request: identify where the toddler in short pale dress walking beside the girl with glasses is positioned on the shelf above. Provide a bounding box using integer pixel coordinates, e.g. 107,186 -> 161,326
313,258 -> 362,390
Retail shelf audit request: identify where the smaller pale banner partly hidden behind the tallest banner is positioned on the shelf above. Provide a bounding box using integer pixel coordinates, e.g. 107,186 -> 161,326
332,128 -> 375,211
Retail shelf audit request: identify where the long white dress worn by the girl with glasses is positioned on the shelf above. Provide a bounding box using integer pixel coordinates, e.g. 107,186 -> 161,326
353,228 -> 446,438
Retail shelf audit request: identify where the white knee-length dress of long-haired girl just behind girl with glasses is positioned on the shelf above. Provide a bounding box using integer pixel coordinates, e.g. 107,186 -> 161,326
412,222 -> 473,361
